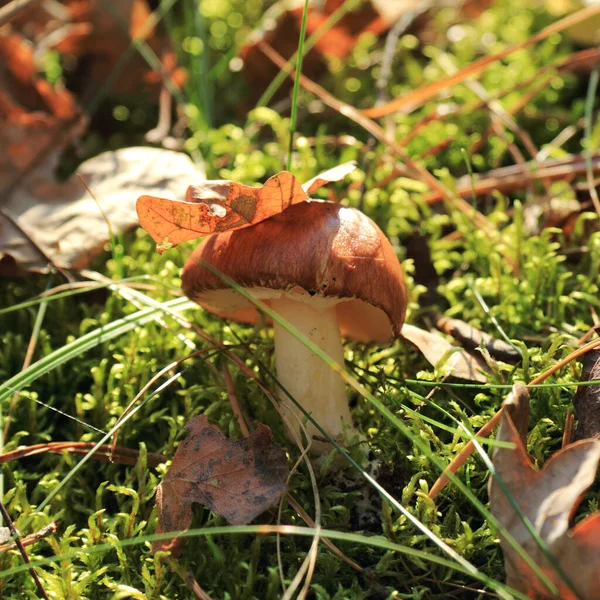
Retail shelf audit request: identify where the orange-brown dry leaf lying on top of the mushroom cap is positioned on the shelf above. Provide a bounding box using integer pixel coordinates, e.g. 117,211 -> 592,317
136,162 -> 356,253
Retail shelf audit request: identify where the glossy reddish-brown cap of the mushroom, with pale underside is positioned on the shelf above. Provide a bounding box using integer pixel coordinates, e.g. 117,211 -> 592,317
182,201 -> 407,342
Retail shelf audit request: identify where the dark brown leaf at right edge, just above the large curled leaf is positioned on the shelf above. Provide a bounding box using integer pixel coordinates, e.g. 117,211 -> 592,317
573,349 -> 600,440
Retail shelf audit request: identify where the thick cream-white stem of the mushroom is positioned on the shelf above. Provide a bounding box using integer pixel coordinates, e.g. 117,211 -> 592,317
271,294 -> 352,453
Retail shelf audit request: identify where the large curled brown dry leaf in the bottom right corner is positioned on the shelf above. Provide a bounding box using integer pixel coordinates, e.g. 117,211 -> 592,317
489,384 -> 600,600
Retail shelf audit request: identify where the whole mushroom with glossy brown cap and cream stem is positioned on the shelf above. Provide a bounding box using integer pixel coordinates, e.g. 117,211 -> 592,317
182,200 -> 407,452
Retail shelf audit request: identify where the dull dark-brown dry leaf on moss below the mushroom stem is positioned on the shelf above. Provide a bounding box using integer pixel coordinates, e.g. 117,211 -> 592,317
153,416 -> 289,552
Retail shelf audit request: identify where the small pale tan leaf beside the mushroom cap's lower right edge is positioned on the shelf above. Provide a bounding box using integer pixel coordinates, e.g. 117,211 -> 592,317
400,323 -> 490,383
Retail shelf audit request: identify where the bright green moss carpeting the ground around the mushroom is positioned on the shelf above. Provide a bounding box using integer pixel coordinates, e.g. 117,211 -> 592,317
0,0 -> 600,600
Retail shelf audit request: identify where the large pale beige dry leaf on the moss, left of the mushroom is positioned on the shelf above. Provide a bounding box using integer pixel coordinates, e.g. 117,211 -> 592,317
0,147 -> 204,275
